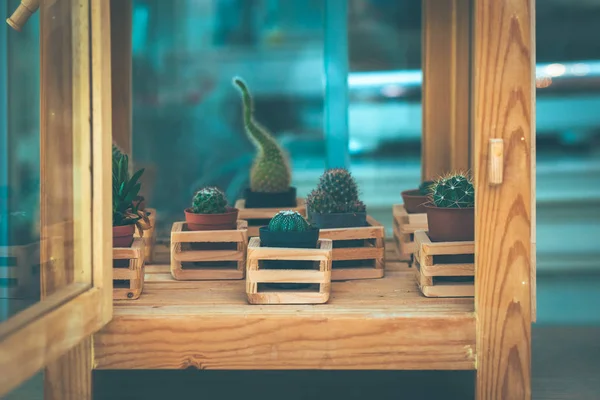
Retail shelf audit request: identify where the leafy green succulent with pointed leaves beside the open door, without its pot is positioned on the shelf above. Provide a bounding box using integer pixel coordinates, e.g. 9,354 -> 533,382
112,154 -> 150,236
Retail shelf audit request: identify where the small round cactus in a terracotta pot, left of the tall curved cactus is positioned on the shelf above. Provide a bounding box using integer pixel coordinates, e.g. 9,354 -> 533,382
185,187 -> 238,231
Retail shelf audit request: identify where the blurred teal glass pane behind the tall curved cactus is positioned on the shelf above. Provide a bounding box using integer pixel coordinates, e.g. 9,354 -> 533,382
133,0 -> 325,238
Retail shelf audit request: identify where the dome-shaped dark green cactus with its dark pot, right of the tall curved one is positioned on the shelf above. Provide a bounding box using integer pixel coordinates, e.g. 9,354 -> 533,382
307,168 -> 367,229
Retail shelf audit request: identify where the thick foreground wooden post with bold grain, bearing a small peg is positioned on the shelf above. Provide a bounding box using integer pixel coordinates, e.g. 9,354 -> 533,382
473,0 -> 535,400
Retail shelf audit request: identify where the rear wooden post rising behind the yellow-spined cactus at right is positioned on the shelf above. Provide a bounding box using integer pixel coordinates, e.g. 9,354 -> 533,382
421,0 -> 471,180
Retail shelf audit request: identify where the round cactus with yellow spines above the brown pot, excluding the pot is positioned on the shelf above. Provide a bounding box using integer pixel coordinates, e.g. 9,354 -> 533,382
431,173 -> 475,208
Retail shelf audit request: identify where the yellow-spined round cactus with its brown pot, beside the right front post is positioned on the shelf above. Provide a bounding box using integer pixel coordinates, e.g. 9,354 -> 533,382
425,173 -> 475,242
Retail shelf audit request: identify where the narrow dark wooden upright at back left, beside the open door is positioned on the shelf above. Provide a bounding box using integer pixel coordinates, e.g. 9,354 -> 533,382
110,0 -> 133,156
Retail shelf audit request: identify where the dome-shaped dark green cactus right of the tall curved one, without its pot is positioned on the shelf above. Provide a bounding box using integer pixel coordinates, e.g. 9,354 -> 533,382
307,168 -> 366,214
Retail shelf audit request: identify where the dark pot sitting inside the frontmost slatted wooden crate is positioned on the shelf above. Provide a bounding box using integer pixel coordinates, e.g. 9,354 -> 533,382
259,226 -> 319,290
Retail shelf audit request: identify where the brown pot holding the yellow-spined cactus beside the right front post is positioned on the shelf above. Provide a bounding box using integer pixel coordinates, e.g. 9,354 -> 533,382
425,205 -> 475,242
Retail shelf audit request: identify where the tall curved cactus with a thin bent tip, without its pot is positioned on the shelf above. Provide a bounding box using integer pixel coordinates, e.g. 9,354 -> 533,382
233,77 -> 292,193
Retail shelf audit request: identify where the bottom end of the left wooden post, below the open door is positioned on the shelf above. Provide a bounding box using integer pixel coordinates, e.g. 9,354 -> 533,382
44,336 -> 92,400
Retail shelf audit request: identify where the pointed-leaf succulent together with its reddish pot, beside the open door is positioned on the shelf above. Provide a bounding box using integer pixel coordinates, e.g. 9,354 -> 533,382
112,153 -> 150,247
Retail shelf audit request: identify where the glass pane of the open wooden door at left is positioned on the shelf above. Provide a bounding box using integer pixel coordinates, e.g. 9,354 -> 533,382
0,0 -> 91,320
